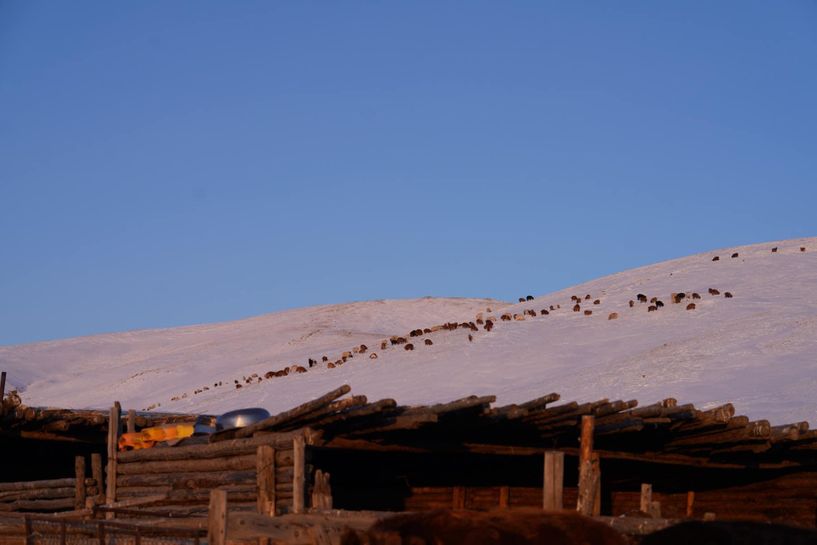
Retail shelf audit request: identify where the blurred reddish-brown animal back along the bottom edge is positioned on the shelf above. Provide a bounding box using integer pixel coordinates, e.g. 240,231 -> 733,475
340,509 -> 628,545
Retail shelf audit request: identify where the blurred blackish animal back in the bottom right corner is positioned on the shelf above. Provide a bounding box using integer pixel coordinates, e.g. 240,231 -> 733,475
641,520 -> 817,545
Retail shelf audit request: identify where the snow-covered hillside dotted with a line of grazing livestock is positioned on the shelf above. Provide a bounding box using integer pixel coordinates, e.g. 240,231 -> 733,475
0,238 -> 817,423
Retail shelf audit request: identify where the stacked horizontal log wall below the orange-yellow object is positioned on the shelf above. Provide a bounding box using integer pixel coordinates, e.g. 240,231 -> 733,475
115,432 -> 310,514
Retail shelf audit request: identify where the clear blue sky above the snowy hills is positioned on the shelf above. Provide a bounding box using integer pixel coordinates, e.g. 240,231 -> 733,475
0,0 -> 817,344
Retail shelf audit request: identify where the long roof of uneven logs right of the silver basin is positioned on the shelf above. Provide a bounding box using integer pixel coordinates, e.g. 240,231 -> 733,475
210,386 -> 817,468
